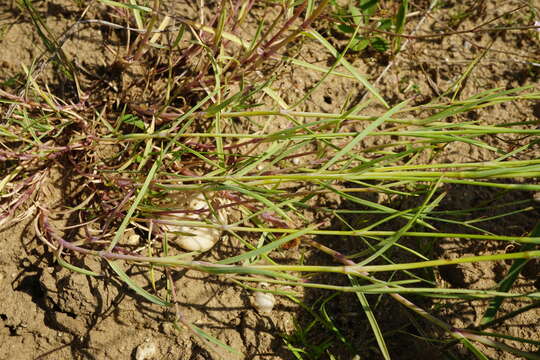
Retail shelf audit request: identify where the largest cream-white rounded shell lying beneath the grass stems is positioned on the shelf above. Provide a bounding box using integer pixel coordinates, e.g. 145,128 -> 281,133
160,192 -> 225,252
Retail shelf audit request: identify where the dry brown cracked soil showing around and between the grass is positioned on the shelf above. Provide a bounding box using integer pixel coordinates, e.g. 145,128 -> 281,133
0,0 -> 540,359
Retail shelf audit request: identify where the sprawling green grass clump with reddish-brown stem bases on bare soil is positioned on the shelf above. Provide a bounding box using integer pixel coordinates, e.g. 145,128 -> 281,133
0,0 -> 540,359
